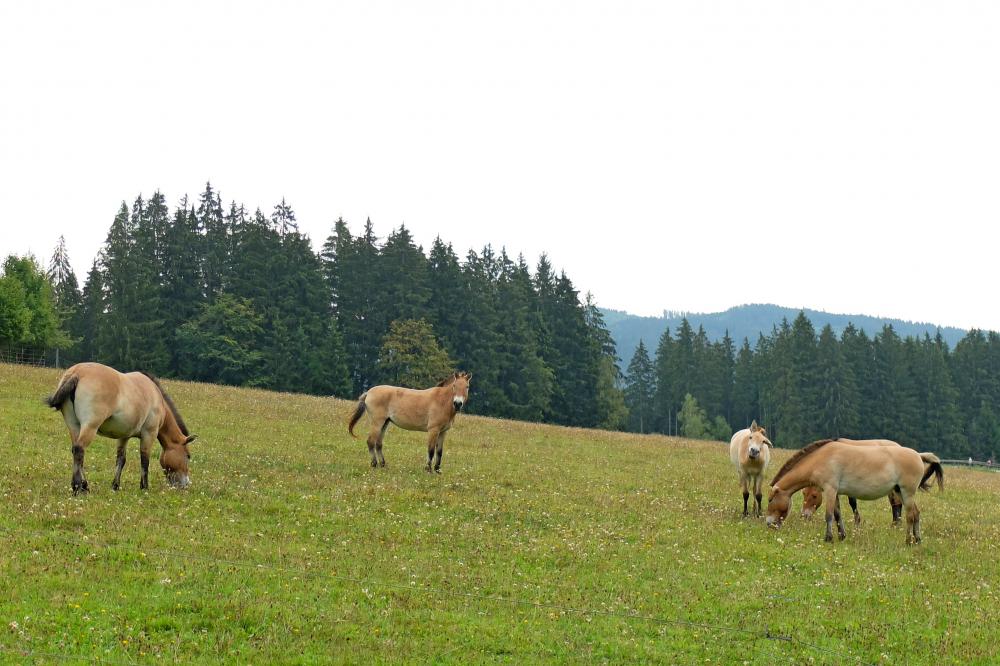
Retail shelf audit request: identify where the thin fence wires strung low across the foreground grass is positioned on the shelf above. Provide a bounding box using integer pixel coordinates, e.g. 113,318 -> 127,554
0,527 -> 869,664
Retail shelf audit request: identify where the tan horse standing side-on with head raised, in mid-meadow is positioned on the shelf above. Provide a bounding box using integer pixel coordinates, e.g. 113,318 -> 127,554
347,372 -> 472,474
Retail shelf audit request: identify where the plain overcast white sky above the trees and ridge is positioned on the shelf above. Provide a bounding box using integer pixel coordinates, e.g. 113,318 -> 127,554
0,0 -> 1000,329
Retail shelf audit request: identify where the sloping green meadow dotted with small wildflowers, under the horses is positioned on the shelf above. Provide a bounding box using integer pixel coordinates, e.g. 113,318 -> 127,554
0,365 -> 1000,664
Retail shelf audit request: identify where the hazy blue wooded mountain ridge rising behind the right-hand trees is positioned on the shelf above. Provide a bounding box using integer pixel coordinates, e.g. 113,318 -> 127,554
601,303 -> 967,369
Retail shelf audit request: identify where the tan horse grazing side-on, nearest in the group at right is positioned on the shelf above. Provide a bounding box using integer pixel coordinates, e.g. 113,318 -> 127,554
767,439 -> 944,544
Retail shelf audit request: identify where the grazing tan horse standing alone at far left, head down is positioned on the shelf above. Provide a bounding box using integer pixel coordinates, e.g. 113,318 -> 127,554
45,363 -> 196,494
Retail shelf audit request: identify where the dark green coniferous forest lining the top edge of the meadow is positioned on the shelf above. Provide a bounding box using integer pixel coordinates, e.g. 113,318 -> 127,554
0,185 -> 1000,460
